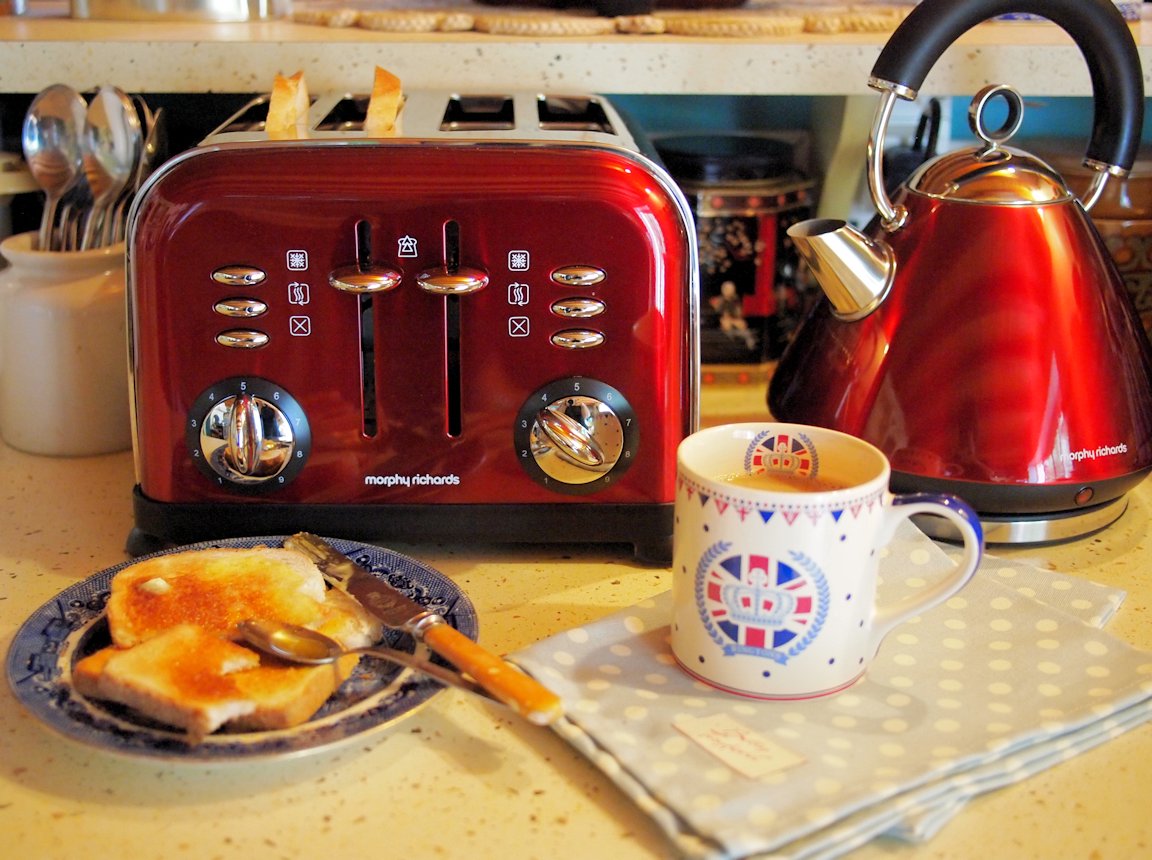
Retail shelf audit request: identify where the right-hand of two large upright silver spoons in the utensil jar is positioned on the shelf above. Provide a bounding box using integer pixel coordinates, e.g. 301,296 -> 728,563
81,86 -> 144,251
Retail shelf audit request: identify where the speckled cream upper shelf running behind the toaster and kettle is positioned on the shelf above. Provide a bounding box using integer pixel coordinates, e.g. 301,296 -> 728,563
0,14 -> 1152,97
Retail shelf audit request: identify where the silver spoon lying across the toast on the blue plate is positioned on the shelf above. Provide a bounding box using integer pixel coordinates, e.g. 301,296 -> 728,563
236,618 -> 495,701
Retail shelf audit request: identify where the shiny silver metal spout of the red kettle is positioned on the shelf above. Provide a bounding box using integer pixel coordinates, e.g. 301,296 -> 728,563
788,218 -> 896,320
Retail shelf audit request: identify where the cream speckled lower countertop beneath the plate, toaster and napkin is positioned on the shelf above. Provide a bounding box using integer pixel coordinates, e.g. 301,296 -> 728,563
0,383 -> 1152,860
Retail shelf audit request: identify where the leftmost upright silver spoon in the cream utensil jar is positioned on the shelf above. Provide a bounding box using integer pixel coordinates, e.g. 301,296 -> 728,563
22,84 -> 86,251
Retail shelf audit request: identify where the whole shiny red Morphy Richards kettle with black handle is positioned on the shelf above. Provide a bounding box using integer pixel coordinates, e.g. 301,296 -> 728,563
768,0 -> 1152,542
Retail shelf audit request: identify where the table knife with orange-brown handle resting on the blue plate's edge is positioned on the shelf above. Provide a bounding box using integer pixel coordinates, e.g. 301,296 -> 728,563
285,532 -> 563,725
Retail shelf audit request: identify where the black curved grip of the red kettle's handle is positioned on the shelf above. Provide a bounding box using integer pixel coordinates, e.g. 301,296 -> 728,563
869,0 -> 1144,176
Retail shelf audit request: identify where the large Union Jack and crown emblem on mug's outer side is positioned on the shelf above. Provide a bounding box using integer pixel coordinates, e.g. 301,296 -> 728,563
696,542 -> 828,664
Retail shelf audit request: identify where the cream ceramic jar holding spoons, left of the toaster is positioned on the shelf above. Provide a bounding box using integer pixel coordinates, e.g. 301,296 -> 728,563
0,233 -> 131,456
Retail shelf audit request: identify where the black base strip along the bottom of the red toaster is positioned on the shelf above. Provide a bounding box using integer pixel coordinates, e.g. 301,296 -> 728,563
126,486 -> 673,565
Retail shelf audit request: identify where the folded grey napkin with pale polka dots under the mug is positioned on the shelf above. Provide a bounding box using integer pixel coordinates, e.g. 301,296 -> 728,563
514,526 -> 1152,859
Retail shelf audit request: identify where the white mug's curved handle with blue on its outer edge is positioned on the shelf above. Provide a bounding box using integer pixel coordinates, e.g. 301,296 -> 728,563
872,493 -> 984,653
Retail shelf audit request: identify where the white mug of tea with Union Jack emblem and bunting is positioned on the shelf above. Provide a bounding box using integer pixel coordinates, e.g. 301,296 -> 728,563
672,423 -> 984,699
